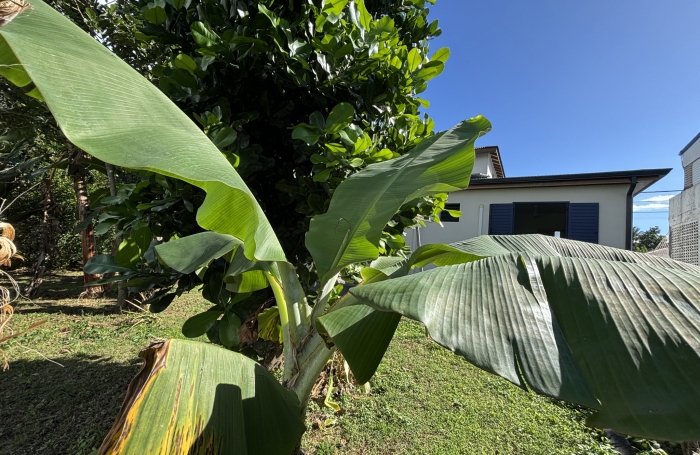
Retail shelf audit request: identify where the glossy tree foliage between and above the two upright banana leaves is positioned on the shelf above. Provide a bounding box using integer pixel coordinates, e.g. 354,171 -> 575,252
122,0 -> 449,280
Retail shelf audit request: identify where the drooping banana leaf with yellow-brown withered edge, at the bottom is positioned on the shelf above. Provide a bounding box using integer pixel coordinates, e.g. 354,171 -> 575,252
99,340 -> 304,455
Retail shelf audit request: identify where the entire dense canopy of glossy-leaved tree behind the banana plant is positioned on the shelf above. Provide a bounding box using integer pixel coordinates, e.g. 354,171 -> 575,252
2,0 -> 449,339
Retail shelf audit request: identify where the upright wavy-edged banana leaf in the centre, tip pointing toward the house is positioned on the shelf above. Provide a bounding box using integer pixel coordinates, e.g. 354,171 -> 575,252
306,116 -> 491,281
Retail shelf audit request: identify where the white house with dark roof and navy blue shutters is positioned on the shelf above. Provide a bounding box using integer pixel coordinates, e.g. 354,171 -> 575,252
406,146 -> 668,249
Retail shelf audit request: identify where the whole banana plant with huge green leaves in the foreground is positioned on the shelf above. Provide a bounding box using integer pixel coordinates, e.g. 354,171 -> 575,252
0,0 -> 700,455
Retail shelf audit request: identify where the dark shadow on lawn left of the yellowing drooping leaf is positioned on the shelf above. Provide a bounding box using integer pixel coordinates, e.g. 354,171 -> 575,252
0,355 -> 141,455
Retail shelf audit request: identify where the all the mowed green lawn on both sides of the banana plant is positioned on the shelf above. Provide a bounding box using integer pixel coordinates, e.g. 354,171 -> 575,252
0,273 -> 614,455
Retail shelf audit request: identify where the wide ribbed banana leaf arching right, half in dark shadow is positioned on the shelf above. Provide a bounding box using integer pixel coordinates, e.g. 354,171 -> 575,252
351,236 -> 700,441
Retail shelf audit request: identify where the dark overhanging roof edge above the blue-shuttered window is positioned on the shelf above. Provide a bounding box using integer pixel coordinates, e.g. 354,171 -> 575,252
468,168 -> 671,195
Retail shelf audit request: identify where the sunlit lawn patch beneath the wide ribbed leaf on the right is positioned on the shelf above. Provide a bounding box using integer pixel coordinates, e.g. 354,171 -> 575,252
304,319 -> 616,455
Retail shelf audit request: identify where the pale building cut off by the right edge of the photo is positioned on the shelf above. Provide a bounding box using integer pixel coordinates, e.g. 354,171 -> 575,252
668,134 -> 700,265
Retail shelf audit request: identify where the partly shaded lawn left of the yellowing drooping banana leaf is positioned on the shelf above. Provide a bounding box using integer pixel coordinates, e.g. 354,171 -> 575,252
0,273 -> 211,455
